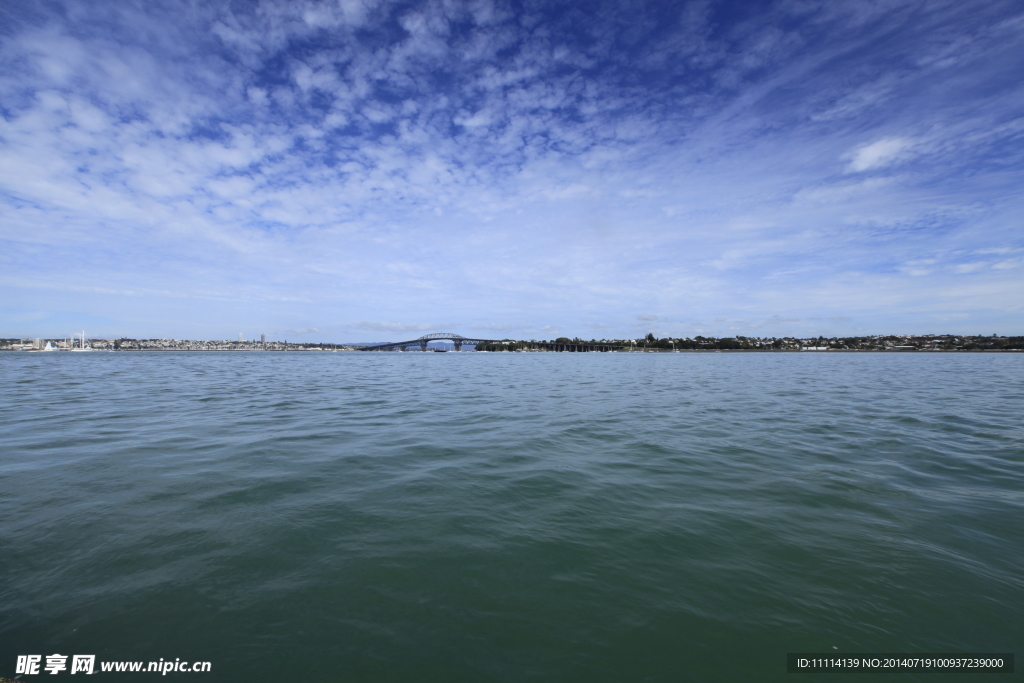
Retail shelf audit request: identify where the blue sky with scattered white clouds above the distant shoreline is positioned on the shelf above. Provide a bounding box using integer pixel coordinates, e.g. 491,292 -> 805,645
0,0 -> 1024,342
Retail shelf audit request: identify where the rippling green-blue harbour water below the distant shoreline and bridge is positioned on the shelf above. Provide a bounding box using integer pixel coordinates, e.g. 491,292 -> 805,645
0,352 -> 1024,681
